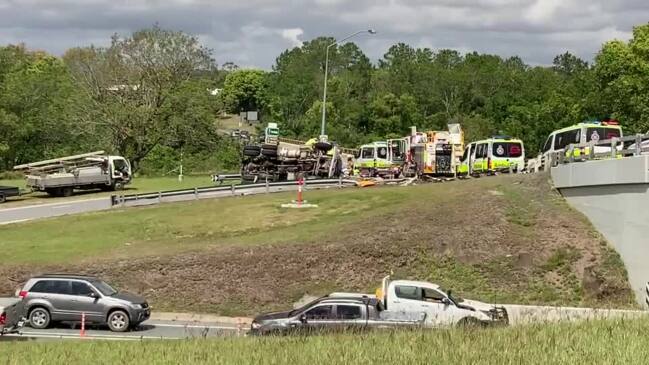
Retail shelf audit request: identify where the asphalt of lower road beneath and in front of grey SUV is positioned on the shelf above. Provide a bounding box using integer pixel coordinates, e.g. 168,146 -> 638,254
0,320 -> 247,341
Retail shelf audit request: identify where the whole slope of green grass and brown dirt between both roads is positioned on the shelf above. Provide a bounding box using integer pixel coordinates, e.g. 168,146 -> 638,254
0,174 -> 633,315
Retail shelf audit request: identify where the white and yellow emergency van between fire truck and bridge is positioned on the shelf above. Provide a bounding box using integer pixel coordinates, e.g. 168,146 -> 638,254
457,136 -> 525,176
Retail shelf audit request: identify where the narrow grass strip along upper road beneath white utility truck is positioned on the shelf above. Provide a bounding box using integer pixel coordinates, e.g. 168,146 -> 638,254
0,175 -> 214,209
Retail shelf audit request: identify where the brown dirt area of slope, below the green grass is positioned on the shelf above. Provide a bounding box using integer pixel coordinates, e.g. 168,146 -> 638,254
0,174 -> 633,315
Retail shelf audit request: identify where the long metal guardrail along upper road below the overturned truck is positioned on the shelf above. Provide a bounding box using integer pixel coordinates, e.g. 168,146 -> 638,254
111,179 -> 356,206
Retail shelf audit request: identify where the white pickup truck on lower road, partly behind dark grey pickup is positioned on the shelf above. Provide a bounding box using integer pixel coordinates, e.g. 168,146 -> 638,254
377,276 -> 508,327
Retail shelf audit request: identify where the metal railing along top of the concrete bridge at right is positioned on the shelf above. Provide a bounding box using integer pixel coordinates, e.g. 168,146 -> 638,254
549,134 -> 649,167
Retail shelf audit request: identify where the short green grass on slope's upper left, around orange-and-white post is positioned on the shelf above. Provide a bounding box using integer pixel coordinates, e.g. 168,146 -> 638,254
0,186 -> 402,264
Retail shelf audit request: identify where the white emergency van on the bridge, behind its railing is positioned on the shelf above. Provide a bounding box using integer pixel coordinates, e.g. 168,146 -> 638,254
528,119 -> 622,171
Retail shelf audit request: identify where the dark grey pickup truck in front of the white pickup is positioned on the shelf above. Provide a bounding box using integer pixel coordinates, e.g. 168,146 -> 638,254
250,293 -> 425,335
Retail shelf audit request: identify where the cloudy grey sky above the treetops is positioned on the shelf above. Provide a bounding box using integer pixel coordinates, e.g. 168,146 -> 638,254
0,0 -> 649,69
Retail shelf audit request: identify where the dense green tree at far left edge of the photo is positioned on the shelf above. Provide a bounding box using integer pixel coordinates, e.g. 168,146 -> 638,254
0,46 -> 89,170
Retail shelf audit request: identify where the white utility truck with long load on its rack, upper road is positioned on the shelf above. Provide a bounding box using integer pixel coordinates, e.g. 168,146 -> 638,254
14,151 -> 132,196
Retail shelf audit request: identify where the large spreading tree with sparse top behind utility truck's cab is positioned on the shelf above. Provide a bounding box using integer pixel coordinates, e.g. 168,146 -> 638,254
64,26 -> 215,170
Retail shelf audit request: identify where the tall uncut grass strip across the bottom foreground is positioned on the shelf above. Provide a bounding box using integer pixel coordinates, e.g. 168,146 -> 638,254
0,320 -> 649,365
